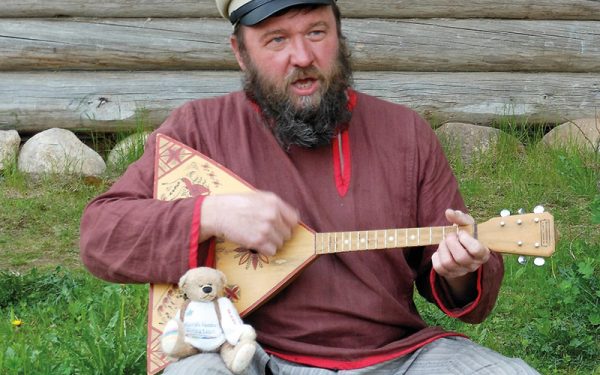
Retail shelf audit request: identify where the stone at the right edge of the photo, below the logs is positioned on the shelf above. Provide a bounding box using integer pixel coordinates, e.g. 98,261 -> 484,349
542,117 -> 600,152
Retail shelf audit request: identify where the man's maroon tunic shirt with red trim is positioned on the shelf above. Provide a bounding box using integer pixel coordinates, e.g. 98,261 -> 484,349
81,92 -> 503,369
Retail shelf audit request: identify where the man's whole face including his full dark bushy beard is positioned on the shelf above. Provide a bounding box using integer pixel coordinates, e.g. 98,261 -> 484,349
231,6 -> 352,148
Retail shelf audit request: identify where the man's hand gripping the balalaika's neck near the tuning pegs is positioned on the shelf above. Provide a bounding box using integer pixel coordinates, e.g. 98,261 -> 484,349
431,209 -> 490,301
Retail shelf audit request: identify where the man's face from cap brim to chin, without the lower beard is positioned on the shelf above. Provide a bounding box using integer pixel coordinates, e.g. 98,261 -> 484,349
232,6 -> 340,109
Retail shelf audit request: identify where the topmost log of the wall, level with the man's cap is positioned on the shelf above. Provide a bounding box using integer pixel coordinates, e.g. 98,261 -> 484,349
0,0 -> 600,20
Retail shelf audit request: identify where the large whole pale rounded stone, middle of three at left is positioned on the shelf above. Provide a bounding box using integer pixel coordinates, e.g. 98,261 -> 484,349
18,128 -> 106,176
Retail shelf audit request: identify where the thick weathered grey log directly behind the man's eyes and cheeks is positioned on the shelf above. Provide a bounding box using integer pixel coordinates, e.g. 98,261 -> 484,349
0,18 -> 600,72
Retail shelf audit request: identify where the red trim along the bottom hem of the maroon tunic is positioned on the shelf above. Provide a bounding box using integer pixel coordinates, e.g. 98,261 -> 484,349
265,332 -> 467,370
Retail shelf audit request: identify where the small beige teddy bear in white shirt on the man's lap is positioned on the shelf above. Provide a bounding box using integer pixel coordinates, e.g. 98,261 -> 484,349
161,267 -> 256,374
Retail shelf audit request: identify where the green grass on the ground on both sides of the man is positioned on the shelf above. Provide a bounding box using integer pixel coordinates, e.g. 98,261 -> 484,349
0,122 -> 600,375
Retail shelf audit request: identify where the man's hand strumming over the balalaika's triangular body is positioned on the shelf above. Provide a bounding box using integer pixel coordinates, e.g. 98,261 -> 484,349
200,191 -> 299,256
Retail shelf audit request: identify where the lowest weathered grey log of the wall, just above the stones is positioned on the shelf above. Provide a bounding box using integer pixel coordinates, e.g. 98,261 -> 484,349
0,72 -> 600,132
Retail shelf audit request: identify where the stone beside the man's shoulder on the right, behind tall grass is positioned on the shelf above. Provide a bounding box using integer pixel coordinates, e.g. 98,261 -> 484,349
435,122 -> 518,163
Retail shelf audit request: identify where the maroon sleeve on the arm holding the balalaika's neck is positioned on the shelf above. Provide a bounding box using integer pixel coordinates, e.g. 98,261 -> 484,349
410,114 -> 504,323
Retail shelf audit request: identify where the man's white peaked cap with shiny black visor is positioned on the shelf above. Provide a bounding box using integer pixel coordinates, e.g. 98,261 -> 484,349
216,0 -> 335,26
